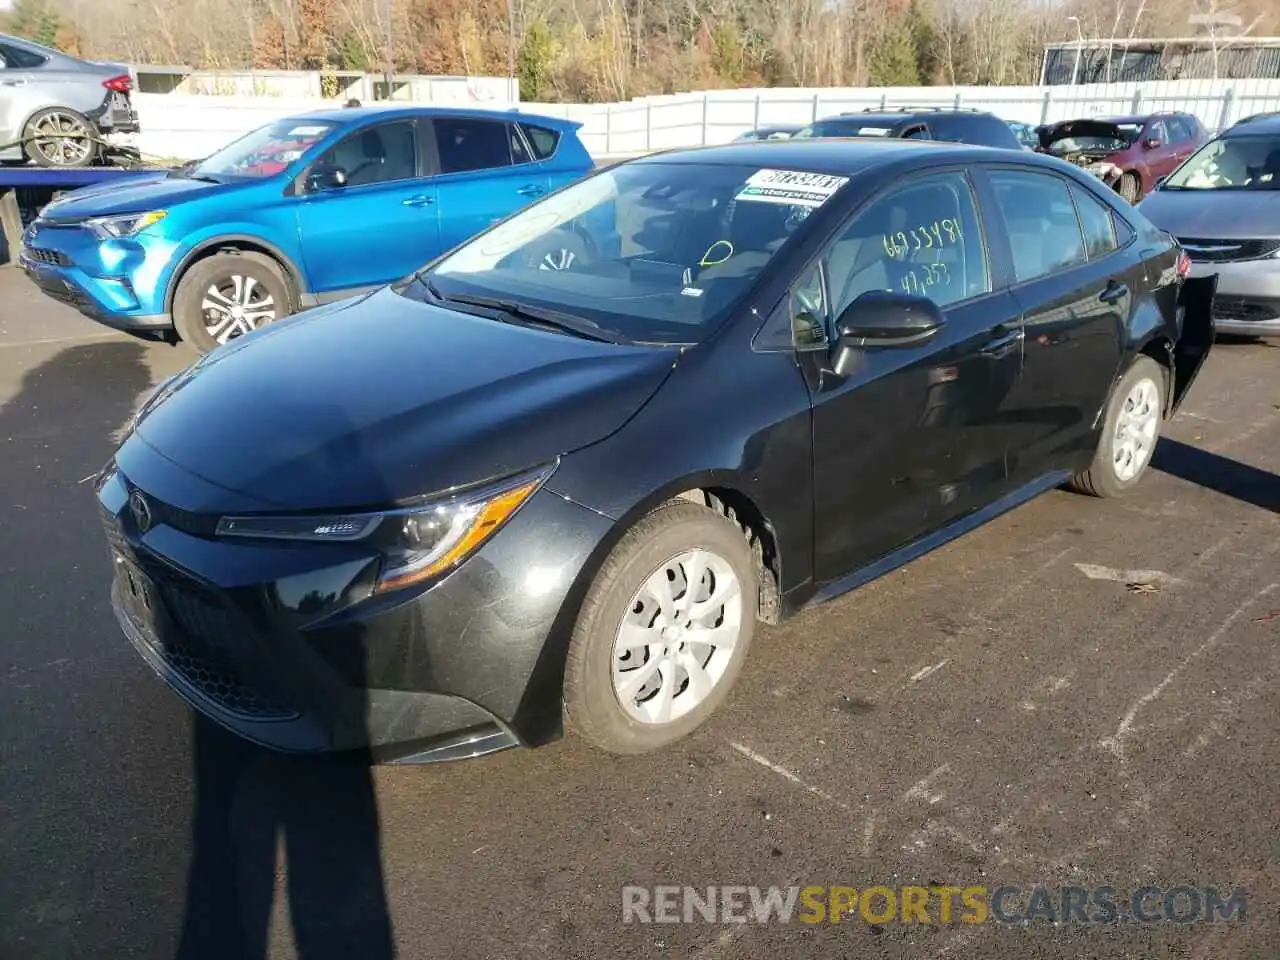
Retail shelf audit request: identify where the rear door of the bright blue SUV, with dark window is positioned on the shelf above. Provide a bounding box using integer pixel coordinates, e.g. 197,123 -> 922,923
430,115 -> 550,250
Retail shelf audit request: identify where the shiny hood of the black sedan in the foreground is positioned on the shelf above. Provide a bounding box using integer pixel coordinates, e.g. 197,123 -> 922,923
129,288 -> 678,509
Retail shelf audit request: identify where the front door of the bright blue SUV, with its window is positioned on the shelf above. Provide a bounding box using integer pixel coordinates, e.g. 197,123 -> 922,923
296,120 -> 440,300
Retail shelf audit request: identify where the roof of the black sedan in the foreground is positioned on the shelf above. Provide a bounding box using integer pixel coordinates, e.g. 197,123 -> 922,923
628,137 -> 1061,177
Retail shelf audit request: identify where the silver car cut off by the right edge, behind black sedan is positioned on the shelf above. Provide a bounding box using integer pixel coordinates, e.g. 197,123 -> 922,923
1138,114 -> 1280,337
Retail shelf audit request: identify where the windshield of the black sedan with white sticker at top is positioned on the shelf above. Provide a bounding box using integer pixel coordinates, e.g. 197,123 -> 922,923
414,160 -> 849,343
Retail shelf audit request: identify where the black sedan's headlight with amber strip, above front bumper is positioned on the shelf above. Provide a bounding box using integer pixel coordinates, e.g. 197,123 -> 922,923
218,463 -> 556,593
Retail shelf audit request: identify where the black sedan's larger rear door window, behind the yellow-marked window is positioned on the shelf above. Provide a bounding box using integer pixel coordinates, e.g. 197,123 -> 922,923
991,170 -> 1085,283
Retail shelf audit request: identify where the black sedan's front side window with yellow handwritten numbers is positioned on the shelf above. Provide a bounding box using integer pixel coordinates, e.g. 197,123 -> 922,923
826,173 -> 988,317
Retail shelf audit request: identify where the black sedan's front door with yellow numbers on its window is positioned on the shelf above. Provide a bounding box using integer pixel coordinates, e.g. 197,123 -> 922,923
801,170 -> 1021,582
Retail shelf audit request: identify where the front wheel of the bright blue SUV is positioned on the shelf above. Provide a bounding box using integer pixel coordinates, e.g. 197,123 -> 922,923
173,251 -> 294,353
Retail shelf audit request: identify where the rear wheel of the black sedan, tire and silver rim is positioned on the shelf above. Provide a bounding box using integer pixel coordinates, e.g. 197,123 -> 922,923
1070,356 -> 1165,497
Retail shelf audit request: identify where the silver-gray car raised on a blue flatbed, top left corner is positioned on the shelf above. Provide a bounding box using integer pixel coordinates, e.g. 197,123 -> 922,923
0,33 -> 138,166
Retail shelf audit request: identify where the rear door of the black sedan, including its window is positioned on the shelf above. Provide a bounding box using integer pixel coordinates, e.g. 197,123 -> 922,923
988,169 -> 1126,483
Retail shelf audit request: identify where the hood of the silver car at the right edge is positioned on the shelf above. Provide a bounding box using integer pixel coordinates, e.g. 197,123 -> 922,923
1138,187 -> 1280,239
